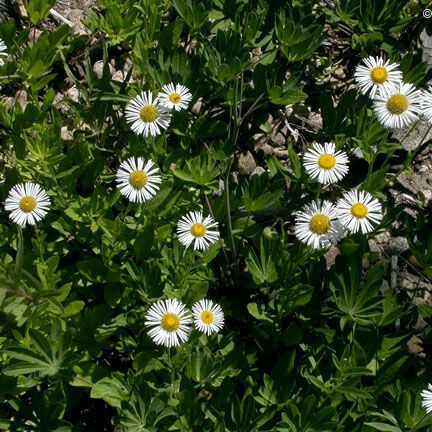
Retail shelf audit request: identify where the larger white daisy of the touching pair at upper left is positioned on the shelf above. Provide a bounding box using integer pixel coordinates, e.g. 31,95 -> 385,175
125,91 -> 171,136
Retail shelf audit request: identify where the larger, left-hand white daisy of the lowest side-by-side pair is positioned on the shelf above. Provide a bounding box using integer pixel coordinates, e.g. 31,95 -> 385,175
144,299 -> 192,348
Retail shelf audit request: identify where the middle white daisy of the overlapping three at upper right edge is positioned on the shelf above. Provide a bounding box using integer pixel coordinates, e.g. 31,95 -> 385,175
373,83 -> 423,129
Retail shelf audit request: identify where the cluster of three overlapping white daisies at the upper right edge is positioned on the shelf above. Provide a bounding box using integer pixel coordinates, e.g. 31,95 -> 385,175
354,56 -> 432,129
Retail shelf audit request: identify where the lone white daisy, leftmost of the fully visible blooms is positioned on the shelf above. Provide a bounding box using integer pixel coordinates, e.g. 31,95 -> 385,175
5,183 -> 51,226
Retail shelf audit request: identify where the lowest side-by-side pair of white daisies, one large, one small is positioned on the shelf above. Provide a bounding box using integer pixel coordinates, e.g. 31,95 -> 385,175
144,299 -> 224,348
